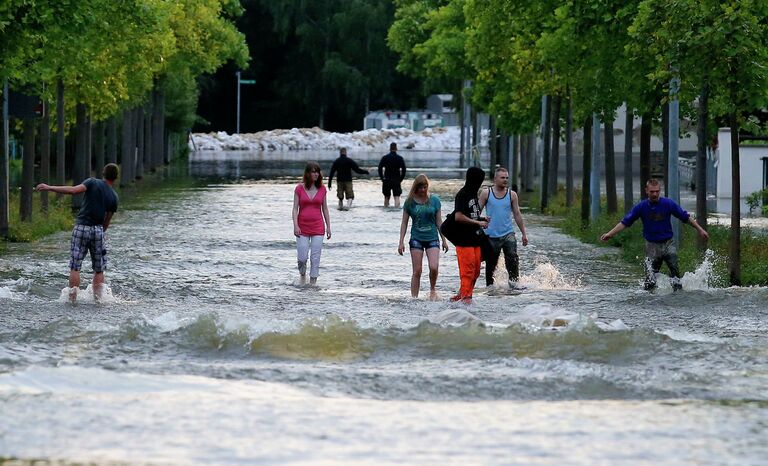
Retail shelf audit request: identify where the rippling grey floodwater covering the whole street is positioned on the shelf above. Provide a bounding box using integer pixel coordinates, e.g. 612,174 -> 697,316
0,153 -> 768,465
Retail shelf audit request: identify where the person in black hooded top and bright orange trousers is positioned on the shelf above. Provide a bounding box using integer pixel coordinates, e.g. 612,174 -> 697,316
451,167 -> 489,304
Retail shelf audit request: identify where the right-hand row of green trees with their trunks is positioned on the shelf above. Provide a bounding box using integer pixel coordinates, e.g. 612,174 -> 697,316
388,0 -> 768,285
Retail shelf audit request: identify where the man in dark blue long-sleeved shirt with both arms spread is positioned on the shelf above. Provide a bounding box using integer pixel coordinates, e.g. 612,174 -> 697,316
600,179 -> 709,291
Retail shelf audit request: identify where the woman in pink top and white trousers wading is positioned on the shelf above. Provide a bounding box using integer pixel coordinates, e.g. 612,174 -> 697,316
293,162 -> 331,285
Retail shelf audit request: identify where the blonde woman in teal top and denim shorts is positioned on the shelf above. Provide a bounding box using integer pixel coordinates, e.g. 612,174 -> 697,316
397,174 -> 448,300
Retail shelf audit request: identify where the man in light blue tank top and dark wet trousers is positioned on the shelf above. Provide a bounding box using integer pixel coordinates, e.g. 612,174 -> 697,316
479,167 -> 528,288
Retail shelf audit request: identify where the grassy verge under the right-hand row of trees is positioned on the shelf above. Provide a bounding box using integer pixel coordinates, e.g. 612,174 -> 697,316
526,187 -> 768,286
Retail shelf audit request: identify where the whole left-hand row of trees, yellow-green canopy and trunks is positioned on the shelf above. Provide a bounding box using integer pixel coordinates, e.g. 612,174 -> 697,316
0,0 -> 248,236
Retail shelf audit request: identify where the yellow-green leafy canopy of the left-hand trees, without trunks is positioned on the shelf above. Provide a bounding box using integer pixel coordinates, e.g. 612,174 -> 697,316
0,0 -> 248,131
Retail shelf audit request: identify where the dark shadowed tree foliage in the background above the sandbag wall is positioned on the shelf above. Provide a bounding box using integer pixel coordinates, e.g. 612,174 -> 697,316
257,0 -> 408,126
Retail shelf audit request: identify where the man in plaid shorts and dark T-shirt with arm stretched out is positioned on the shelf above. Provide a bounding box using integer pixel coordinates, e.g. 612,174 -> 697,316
36,163 -> 120,304
